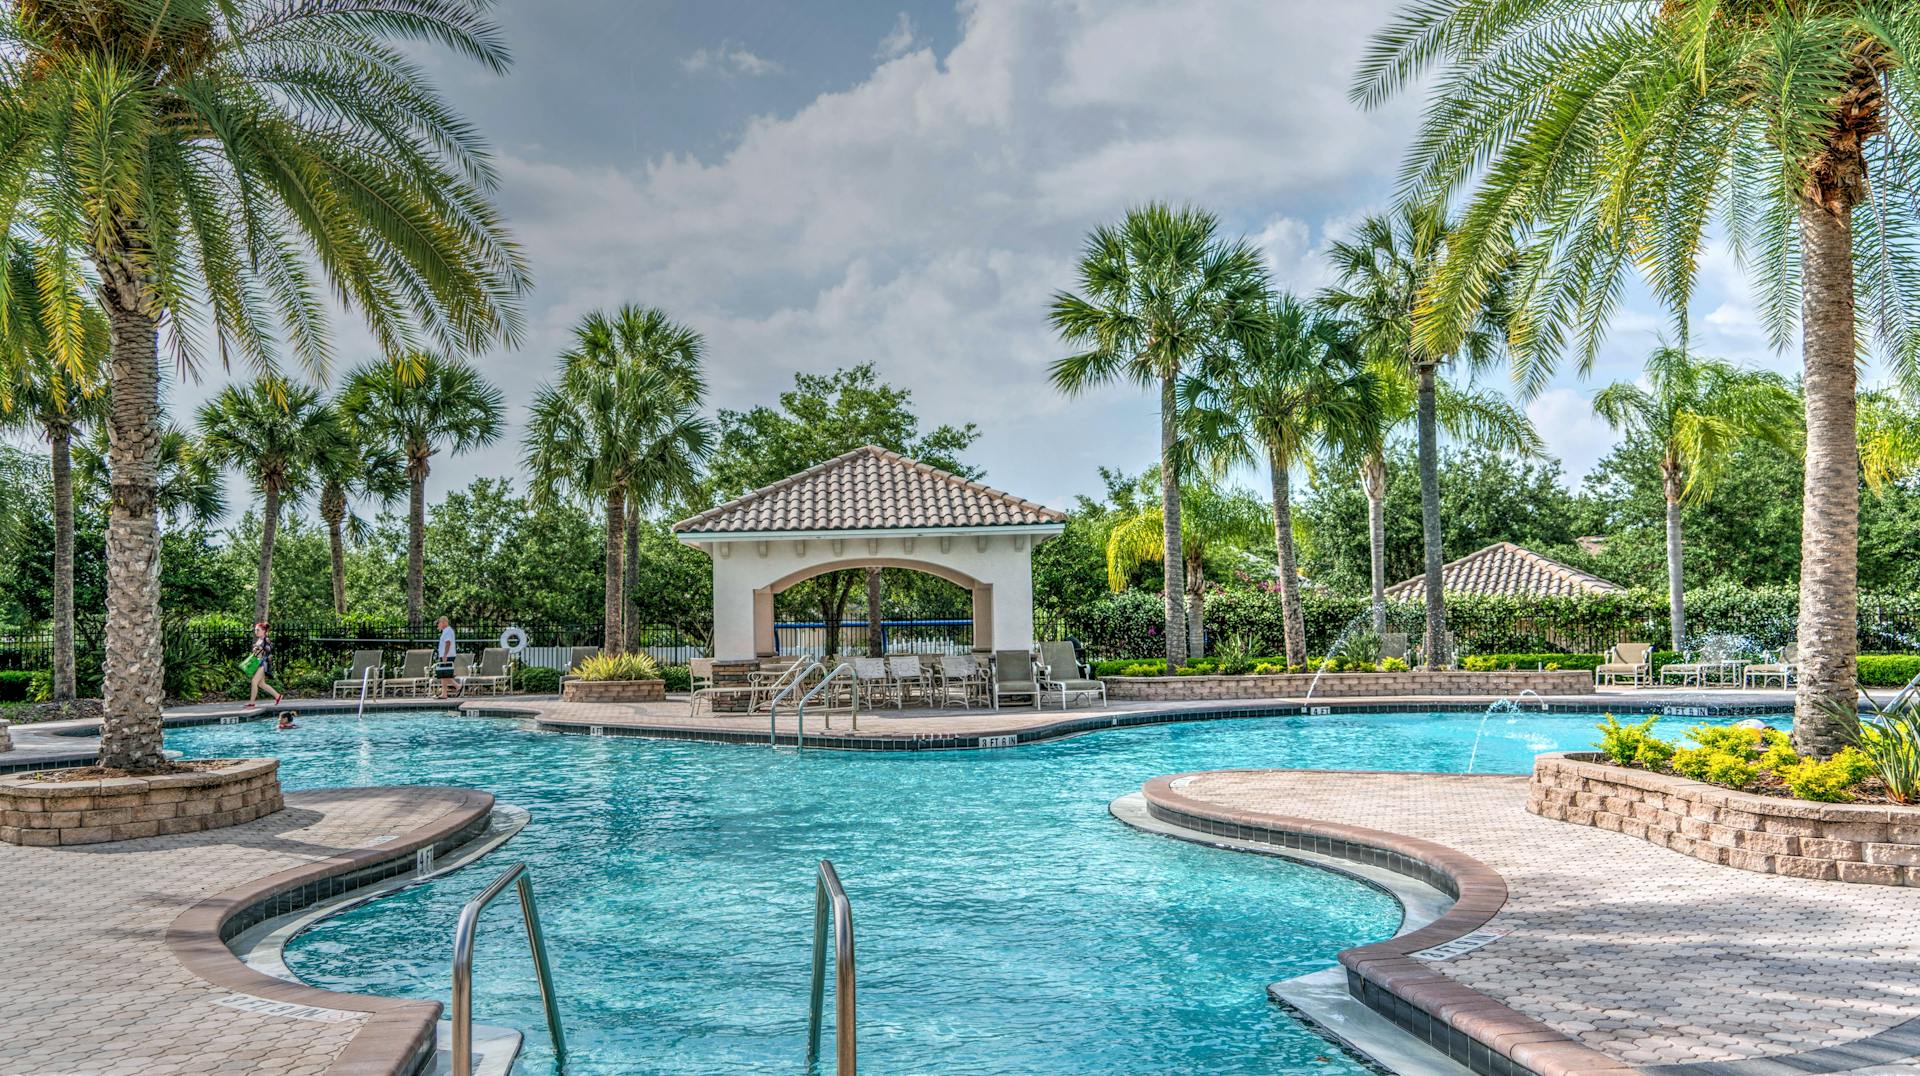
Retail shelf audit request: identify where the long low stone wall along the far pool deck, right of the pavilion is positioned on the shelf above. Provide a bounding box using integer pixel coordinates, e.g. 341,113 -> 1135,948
1106,669 -> 1594,701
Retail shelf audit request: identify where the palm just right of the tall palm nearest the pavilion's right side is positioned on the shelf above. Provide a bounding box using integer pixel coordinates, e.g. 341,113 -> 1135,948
1187,294 -> 1379,665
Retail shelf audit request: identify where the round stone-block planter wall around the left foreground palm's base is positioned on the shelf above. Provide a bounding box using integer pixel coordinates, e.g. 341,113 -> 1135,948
0,759 -> 284,845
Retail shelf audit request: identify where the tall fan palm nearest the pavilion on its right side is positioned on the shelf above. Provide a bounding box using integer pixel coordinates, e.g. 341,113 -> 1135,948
1048,202 -> 1267,667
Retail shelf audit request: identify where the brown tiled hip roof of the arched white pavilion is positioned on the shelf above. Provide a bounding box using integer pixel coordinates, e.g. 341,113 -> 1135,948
674,444 -> 1066,534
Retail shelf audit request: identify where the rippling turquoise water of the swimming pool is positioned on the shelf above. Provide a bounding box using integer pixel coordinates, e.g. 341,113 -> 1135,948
167,713 -> 1781,1076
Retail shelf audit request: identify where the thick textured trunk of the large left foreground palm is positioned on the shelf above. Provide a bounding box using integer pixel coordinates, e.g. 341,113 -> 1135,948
94,269 -> 167,772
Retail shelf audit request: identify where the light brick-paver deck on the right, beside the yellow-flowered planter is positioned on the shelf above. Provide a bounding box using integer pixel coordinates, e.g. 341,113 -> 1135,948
1144,770 -> 1920,1076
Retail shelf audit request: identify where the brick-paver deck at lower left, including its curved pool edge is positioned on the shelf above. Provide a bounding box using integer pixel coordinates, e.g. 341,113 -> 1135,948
0,788 -> 492,1076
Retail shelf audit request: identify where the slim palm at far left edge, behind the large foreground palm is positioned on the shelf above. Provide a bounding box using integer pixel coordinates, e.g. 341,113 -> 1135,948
0,238 -> 109,703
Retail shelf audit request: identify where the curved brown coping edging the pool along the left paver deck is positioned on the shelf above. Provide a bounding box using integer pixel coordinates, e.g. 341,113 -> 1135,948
167,788 -> 493,1076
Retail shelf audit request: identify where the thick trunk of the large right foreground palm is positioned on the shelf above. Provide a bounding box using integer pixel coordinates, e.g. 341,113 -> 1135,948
1793,191 -> 1864,757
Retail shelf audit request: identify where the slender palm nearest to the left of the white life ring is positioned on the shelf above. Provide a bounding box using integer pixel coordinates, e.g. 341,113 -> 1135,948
340,352 -> 507,624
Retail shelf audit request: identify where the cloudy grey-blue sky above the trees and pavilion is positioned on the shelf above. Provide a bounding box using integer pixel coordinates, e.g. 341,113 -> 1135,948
153,0 -> 1795,507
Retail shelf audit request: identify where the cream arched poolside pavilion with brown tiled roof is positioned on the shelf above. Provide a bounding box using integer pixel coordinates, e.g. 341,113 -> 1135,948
674,446 -> 1066,663
